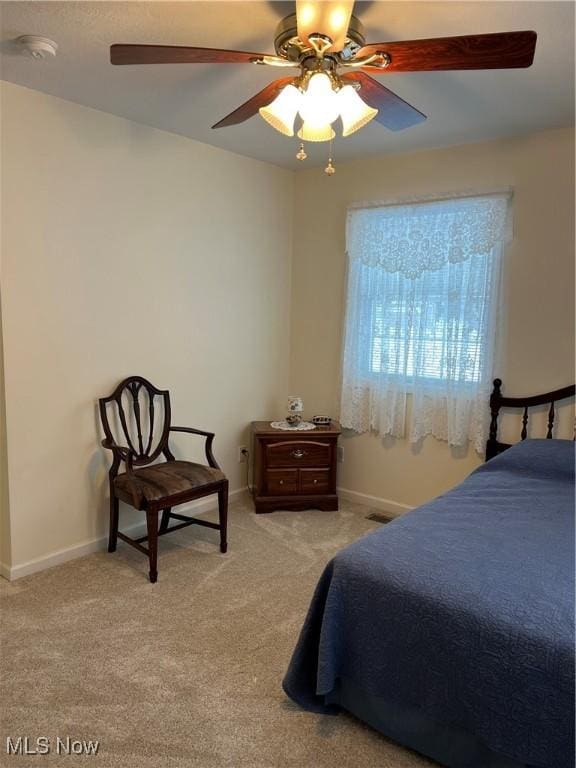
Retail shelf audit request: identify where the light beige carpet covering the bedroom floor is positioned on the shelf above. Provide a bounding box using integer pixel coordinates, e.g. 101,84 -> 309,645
0,500 -> 433,768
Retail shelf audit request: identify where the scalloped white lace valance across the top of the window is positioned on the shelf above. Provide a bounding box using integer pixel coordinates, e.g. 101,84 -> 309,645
346,193 -> 512,279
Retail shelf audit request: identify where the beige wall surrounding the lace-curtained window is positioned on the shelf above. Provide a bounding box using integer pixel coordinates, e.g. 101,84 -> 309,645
290,129 -> 574,505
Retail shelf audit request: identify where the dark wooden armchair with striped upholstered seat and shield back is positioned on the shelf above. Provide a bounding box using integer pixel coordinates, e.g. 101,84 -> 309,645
99,376 -> 228,583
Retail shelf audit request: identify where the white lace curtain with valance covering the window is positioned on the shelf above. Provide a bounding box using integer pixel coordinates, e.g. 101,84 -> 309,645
341,194 -> 511,453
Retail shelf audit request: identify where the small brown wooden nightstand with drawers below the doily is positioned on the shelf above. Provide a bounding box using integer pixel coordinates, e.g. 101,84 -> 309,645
252,421 -> 341,512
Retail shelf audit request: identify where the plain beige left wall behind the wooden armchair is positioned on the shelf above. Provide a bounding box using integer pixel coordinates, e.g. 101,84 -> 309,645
1,84 -> 292,567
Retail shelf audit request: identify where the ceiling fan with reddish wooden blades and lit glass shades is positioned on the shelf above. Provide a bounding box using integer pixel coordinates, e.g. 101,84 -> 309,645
110,0 -> 536,174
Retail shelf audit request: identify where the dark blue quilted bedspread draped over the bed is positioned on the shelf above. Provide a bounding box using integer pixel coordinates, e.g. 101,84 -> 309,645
284,440 -> 574,768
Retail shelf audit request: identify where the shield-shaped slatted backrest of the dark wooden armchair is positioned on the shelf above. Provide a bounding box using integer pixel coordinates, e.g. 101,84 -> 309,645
98,376 -> 170,465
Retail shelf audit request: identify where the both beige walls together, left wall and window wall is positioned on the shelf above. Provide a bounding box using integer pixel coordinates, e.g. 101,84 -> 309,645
0,84 -> 574,570
